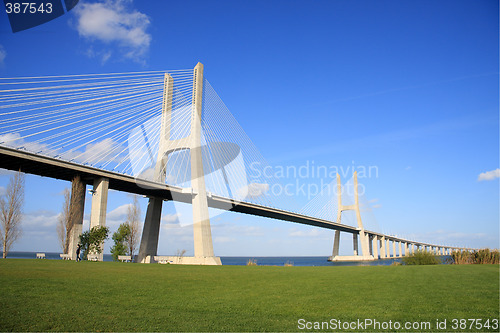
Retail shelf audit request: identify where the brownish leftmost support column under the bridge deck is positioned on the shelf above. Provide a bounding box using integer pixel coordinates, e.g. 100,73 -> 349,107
68,177 -> 86,260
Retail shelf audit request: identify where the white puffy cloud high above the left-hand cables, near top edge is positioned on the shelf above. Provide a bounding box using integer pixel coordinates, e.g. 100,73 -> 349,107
74,0 -> 151,62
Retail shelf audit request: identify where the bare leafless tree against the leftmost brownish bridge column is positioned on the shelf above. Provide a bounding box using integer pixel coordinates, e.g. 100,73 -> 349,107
57,176 -> 83,253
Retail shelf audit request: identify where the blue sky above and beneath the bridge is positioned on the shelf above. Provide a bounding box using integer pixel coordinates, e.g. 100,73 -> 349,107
0,0 -> 500,256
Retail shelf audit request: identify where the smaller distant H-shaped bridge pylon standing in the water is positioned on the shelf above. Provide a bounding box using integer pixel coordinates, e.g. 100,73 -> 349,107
328,171 -> 375,261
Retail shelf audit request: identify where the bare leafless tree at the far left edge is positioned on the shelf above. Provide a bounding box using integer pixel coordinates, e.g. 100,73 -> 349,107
0,172 -> 24,258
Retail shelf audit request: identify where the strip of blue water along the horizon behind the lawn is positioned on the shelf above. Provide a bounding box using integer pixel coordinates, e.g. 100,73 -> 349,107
0,252 -> 449,266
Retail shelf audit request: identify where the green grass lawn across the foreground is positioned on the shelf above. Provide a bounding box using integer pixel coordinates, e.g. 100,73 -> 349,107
0,259 -> 499,331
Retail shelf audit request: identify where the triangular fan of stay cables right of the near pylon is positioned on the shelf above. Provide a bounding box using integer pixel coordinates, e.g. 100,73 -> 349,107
201,80 -> 298,211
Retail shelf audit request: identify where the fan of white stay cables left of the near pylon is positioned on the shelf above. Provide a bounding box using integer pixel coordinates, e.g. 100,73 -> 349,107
0,70 -> 192,174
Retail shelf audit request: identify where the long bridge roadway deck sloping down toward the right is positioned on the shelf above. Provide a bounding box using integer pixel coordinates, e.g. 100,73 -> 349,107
0,146 -> 460,249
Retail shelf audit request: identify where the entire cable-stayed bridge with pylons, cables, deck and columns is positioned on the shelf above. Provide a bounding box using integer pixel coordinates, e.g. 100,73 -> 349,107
0,63 -> 474,264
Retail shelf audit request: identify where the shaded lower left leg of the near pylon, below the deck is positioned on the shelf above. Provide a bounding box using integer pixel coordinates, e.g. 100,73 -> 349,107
137,197 -> 163,264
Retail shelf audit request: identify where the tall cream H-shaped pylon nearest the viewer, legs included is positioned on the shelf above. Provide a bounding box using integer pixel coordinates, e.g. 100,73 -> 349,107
137,63 -> 221,265
